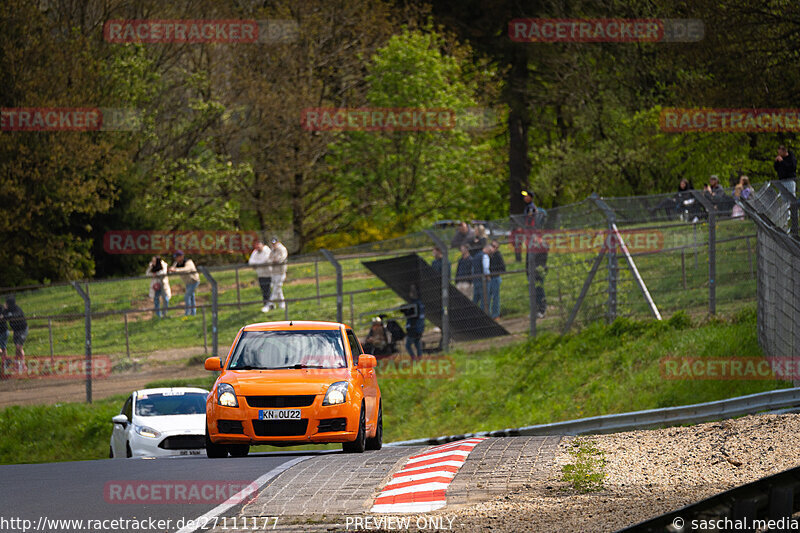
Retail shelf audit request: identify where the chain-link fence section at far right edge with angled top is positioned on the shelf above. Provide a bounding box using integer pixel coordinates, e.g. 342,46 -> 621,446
744,182 -> 800,385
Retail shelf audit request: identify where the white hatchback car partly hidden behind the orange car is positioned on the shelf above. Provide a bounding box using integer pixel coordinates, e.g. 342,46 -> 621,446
109,387 -> 208,458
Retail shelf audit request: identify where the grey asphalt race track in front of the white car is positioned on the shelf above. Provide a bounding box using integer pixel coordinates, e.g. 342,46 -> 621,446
0,451 -> 328,531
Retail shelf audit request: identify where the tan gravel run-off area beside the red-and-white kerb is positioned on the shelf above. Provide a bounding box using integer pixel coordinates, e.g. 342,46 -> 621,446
404,414 -> 800,532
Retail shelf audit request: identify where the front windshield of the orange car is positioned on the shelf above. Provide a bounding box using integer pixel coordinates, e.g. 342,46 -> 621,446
228,329 -> 347,370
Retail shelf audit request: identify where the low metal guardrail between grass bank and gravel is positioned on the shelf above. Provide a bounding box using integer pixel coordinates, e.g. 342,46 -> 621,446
386,387 -> 800,446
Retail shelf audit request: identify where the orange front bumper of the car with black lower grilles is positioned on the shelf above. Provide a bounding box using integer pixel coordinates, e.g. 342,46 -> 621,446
206,395 -> 360,445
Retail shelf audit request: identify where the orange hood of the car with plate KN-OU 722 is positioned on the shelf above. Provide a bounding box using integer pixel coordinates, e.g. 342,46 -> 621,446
222,368 -> 351,396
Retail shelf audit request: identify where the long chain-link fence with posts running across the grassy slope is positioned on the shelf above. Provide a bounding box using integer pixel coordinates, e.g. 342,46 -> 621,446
0,186 -> 760,403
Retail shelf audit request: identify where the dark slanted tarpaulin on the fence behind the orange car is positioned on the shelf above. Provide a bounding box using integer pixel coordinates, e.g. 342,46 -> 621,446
362,254 -> 508,341
